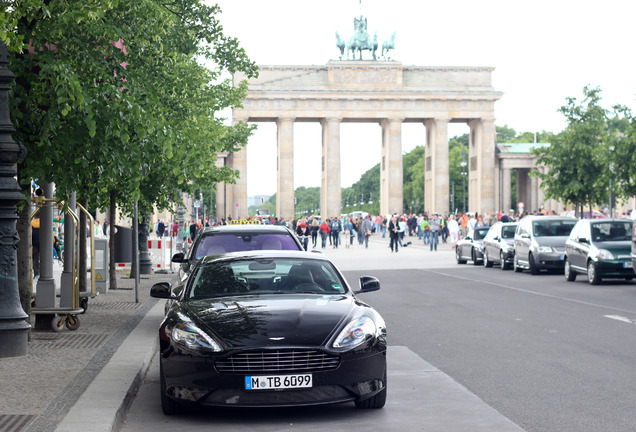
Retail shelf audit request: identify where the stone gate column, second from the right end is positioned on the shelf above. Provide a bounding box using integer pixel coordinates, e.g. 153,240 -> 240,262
424,118 -> 450,212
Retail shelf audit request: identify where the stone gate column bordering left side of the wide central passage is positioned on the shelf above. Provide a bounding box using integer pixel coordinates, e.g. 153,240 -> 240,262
320,117 -> 342,219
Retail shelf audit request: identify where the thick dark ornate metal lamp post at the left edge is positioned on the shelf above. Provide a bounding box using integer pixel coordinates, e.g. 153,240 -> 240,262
0,42 -> 31,357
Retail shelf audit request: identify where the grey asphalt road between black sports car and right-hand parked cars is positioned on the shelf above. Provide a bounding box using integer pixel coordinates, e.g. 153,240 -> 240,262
117,240 -> 636,432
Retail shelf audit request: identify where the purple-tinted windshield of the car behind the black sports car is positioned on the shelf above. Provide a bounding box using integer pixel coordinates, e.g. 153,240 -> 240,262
192,233 -> 299,259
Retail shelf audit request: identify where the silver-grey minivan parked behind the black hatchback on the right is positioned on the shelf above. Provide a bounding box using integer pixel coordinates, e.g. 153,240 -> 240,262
513,215 -> 577,275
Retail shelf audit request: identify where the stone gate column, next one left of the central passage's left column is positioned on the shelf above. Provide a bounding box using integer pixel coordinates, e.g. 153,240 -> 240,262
276,117 -> 294,221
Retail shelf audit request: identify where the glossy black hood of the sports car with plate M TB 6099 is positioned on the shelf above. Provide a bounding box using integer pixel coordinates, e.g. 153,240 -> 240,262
185,294 -> 356,348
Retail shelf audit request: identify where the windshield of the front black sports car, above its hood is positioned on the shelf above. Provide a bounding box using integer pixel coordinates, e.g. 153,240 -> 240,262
187,258 -> 347,298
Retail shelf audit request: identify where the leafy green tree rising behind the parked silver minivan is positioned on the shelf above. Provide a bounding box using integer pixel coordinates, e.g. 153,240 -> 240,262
531,87 -> 609,216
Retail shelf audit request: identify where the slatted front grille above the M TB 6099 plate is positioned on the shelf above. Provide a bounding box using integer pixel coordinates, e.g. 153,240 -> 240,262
215,350 -> 340,373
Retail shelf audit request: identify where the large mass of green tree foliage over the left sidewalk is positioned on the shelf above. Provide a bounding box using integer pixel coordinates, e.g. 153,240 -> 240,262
8,0 -> 257,213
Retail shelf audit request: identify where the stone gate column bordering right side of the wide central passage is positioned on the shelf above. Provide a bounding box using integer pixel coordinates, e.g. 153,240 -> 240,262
380,118 -> 404,215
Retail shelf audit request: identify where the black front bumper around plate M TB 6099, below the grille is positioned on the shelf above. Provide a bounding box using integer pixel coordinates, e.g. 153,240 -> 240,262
160,347 -> 386,407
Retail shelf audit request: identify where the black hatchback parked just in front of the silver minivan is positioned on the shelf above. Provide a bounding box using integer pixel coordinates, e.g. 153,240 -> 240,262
564,219 -> 634,285
